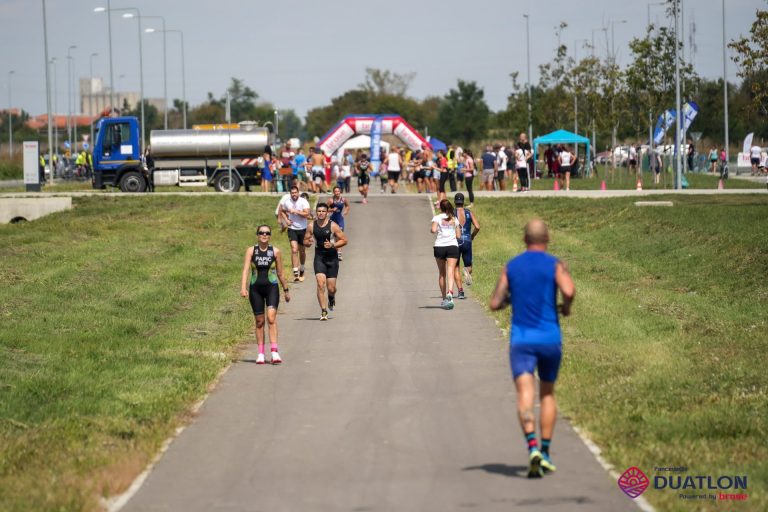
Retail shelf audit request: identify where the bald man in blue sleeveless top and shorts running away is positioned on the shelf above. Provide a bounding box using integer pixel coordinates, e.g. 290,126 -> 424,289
489,219 -> 576,478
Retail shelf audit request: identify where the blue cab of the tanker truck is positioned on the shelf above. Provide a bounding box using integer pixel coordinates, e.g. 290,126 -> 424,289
92,117 -> 151,192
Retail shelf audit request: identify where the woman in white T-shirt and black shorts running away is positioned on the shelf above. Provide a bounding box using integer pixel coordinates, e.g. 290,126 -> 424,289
432,199 -> 461,309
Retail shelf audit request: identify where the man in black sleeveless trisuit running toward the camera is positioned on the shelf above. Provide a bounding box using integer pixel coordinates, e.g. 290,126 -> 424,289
304,203 -> 347,320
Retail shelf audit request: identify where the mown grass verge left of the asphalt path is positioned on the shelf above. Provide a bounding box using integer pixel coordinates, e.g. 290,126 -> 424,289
0,194 -> 290,511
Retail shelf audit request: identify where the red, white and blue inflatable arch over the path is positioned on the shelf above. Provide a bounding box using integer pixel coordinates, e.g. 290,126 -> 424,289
317,114 -> 431,162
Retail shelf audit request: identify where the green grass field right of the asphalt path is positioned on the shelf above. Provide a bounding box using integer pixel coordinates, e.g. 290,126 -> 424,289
473,195 -> 768,510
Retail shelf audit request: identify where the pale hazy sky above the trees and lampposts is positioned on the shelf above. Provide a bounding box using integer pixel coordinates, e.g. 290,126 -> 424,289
0,0 -> 768,115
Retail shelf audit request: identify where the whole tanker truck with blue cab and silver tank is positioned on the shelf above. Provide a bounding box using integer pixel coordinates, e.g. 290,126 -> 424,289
92,117 -> 269,192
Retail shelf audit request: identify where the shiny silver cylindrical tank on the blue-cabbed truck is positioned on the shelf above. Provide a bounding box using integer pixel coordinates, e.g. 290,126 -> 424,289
149,128 -> 269,158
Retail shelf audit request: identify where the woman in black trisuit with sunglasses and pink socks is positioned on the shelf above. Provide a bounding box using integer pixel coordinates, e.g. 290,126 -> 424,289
240,224 -> 291,364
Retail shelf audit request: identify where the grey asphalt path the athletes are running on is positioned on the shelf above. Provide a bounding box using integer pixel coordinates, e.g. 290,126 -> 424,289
123,196 -> 637,512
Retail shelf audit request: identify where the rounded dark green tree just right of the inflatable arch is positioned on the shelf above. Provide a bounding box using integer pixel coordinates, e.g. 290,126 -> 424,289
434,80 -> 490,145
